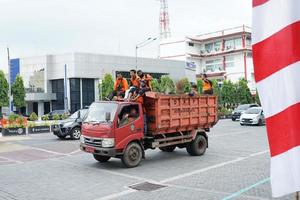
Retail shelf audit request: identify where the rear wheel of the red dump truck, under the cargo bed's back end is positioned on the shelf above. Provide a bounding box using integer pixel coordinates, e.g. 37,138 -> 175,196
186,135 -> 207,156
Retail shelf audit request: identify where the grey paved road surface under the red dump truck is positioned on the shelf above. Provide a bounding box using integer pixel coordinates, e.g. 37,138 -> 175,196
0,120 -> 293,200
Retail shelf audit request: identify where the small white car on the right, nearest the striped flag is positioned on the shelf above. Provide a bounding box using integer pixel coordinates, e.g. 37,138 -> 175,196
240,107 -> 265,126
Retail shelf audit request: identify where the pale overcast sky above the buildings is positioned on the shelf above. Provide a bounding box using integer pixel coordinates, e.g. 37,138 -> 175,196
0,0 -> 252,71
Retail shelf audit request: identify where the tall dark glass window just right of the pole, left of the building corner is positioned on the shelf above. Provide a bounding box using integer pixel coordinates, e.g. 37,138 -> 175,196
70,78 -> 81,113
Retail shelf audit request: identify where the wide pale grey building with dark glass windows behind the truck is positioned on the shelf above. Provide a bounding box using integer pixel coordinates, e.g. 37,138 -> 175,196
10,53 -> 189,116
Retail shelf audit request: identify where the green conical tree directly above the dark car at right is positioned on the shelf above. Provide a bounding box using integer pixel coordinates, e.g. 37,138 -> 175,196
236,79 -> 253,104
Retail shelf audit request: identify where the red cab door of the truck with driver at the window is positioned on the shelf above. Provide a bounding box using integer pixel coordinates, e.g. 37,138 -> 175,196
115,104 -> 144,149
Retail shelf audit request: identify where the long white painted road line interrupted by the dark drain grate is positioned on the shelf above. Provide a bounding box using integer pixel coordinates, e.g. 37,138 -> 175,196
95,150 -> 269,200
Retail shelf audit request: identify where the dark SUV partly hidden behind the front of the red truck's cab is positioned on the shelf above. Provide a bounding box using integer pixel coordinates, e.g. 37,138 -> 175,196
53,109 -> 88,140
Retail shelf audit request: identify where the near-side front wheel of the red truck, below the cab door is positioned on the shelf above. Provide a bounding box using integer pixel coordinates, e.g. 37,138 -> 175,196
121,142 -> 143,168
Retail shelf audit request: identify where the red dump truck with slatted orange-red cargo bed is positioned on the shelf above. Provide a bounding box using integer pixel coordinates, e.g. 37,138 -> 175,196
80,92 -> 217,167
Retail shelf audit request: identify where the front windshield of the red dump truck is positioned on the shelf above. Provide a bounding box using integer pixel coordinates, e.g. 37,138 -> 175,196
84,103 -> 118,123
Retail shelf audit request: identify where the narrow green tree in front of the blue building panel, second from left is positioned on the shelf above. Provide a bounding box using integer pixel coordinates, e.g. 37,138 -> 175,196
11,75 -> 26,111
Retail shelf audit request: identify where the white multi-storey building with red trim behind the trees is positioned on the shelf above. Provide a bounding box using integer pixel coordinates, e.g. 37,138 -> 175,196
160,26 -> 256,93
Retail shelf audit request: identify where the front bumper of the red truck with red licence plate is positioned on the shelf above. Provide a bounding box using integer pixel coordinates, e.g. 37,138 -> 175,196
80,143 -> 123,157
